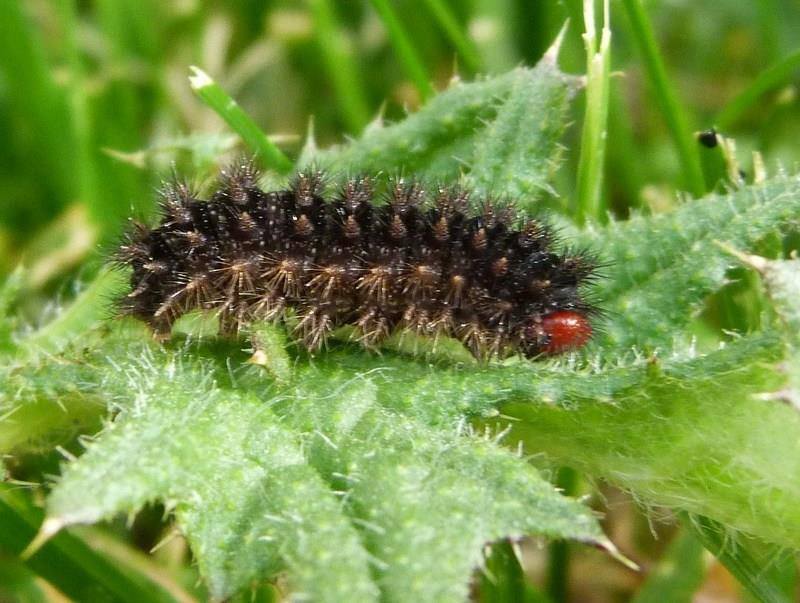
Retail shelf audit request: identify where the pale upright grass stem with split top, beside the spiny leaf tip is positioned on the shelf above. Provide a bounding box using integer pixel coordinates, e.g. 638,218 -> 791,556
575,0 -> 611,224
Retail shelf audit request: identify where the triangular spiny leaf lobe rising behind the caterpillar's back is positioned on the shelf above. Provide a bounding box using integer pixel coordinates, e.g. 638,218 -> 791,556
300,51 -> 578,202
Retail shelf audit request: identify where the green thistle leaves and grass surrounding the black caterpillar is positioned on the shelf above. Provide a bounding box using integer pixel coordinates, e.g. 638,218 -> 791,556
0,0 -> 800,601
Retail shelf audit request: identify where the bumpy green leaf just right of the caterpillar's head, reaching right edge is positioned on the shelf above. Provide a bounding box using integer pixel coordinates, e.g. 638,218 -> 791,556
577,177 -> 800,351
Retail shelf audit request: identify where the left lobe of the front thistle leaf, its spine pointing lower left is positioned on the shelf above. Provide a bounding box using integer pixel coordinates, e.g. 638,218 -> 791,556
49,359 -> 376,601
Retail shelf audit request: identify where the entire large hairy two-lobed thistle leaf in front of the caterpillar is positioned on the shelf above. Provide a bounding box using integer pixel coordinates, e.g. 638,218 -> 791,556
43,340 -> 613,601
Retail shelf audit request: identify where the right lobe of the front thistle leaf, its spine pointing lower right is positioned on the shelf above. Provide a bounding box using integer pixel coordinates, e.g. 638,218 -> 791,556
287,372 -> 610,601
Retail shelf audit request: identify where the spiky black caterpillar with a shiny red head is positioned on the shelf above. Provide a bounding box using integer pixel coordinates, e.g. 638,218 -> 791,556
117,161 -> 596,359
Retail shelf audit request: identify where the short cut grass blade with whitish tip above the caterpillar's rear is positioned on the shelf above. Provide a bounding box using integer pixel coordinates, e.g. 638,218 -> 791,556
189,66 -> 292,174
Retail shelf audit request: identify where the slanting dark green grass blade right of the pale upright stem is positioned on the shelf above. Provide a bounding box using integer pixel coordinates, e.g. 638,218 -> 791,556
622,0 -> 706,197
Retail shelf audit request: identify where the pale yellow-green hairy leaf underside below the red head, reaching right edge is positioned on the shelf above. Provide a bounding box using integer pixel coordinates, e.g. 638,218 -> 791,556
498,335 -> 800,547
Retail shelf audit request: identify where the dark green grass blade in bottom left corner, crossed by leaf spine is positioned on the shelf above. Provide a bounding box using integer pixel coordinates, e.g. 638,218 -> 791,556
0,484 -> 184,603
